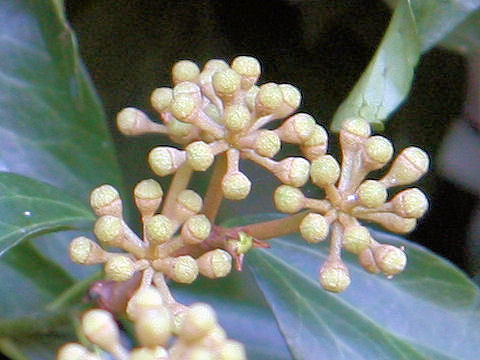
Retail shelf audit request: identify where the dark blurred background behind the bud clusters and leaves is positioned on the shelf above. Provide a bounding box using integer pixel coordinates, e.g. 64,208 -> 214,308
66,0 -> 480,276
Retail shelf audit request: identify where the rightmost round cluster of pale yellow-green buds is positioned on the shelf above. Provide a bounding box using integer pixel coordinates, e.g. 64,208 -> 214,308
274,118 -> 429,292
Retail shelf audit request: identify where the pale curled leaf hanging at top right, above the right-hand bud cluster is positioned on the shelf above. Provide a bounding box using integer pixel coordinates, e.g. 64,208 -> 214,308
331,0 -> 480,131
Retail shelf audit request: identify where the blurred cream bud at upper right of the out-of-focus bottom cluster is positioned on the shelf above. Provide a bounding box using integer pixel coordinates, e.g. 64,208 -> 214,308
179,303 -> 217,342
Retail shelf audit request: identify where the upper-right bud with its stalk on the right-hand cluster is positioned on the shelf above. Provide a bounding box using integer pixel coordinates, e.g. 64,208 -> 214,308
380,146 -> 430,187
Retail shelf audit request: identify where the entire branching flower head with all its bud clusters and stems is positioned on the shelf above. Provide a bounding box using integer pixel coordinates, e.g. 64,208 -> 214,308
58,56 -> 429,360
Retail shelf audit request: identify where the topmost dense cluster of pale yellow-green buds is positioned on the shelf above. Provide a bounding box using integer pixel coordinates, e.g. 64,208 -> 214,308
117,56 -> 327,200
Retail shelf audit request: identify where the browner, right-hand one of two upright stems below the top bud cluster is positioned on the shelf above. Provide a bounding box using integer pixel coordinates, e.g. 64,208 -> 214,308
203,154 -> 227,223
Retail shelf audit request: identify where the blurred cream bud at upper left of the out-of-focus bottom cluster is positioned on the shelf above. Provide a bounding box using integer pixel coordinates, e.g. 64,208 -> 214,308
82,309 -> 121,353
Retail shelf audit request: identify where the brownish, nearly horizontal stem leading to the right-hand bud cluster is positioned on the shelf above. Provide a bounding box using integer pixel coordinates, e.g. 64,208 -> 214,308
238,211 -> 308,240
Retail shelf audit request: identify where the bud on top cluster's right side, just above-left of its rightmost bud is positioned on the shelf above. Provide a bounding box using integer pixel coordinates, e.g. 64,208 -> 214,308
275,113 -> 315,144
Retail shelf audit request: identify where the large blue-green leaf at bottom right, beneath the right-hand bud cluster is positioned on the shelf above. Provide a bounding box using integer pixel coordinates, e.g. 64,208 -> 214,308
247,217 -> 480,360
